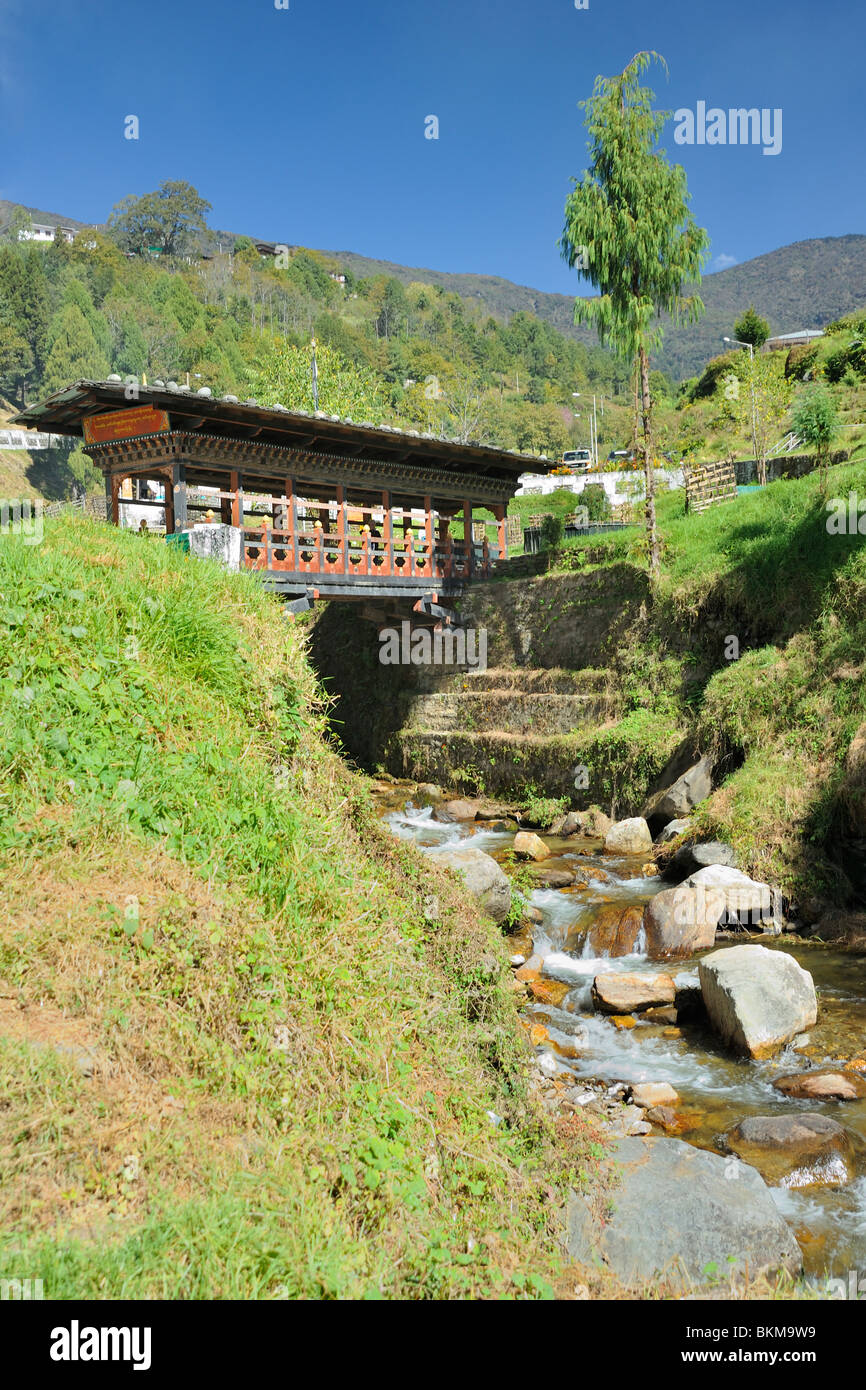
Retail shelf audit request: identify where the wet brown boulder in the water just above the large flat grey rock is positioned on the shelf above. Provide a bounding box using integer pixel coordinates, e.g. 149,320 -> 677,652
724,1111 -> 852,1187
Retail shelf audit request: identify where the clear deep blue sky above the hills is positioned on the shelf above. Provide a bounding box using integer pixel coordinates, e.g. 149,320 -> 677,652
0,0 -> 866,293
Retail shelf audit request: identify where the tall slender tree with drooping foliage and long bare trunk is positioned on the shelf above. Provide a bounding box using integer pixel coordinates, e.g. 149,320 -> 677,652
560,51 -> 709,582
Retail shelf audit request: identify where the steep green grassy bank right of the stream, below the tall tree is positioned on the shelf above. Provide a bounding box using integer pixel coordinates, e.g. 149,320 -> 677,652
530,446 -> 866,912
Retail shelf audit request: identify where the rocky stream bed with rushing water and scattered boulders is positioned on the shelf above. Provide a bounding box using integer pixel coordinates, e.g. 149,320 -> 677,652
374,781 -> 866,1289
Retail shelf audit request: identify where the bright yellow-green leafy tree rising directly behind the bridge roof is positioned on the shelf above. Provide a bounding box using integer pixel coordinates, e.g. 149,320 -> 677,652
252,339 -> 385,424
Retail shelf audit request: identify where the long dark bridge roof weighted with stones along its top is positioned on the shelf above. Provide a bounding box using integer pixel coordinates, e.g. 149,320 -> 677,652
15,377 -> 556,485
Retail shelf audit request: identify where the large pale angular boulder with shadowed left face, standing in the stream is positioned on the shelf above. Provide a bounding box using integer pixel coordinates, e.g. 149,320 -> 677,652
698,945 -> 817,1058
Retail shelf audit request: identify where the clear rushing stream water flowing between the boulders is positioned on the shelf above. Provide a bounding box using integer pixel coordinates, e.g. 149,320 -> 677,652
374,784 -> 866,1279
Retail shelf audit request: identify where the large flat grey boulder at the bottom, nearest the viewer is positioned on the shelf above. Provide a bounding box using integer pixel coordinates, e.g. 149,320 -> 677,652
566,1138 -> 802,1287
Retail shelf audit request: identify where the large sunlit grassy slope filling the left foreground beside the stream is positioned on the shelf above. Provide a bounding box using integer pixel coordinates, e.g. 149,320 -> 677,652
0,521 -> 603,1297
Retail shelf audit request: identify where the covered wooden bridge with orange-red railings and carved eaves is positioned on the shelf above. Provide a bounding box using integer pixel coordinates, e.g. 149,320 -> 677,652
18,378 -> 550,617
